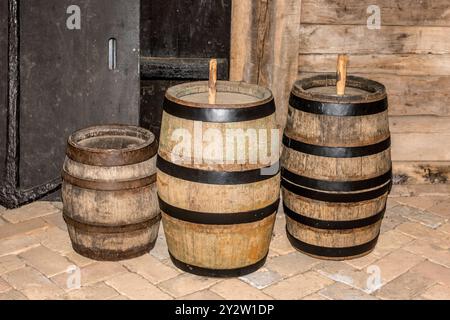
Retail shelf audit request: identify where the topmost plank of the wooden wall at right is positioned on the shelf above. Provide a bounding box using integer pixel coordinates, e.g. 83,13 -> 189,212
301,0 -> 450,26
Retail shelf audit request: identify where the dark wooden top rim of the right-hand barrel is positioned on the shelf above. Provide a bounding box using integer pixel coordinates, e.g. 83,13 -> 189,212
292,73 -> 387,103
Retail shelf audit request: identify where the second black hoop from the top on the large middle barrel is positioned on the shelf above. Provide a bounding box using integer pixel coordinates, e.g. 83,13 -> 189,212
156,155 -> 279,185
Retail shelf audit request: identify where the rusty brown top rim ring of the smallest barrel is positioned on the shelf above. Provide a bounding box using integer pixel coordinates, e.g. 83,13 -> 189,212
66,124 -> 158,166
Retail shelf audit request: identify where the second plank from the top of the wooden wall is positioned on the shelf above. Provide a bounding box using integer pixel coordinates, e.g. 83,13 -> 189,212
299,25 -> 450,55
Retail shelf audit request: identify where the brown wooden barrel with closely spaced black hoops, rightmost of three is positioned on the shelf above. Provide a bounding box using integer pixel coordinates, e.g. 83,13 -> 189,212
282,75 -> 392,260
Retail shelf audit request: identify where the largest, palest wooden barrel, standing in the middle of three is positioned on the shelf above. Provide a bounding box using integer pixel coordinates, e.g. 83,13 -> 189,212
157,81 -> 280,277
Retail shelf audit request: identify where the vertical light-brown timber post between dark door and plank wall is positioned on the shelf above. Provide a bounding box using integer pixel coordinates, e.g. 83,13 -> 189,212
230,0 -> 301,127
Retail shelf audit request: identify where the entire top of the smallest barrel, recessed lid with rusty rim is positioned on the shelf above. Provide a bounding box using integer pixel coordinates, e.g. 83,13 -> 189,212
67,124 -> 158,167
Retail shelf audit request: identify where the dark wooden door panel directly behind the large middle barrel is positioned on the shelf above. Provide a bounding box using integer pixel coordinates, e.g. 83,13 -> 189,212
140,0 -> 231,135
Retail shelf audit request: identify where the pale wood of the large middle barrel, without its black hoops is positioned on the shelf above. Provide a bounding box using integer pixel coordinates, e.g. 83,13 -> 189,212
157,81 -> 280,272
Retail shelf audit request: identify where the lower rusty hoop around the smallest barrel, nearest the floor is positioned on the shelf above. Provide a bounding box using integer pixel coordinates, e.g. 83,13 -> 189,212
63,212 -> 161,234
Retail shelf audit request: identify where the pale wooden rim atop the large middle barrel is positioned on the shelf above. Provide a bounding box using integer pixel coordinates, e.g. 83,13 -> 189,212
165,80 -> 274,110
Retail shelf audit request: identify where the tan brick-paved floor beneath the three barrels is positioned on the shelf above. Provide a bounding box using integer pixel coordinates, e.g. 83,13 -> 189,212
0,192 -> 450,300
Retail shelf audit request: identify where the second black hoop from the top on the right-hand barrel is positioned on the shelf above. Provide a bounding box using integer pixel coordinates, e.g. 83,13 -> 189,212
283,135 -> 391,158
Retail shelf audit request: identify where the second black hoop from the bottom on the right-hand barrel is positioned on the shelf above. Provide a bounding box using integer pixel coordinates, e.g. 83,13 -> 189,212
283,204 -> 386,230
